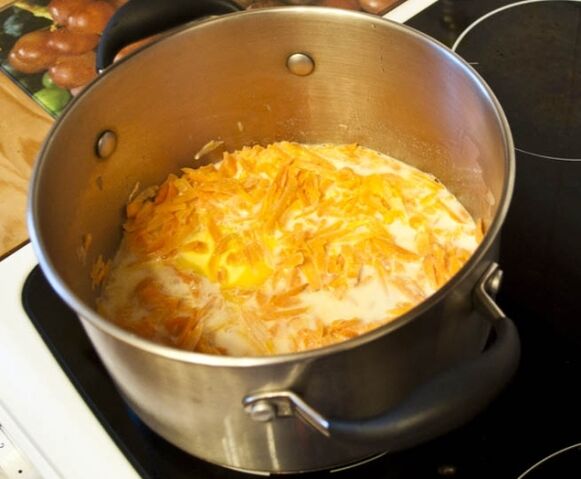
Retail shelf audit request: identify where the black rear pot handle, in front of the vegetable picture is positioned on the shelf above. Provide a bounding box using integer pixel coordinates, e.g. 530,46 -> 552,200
97,0 -> 242,72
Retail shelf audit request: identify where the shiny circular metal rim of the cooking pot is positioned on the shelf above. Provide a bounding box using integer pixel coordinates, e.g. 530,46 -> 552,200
26,6 -> 516,367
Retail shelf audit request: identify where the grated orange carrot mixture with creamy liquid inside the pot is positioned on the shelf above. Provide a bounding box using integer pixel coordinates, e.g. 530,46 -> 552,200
98,142 -> 483,356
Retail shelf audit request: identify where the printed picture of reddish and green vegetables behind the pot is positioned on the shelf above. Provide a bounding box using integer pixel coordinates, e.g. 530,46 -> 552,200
0,0 -> 124,117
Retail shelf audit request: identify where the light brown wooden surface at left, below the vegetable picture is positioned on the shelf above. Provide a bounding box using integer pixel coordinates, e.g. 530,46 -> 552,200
0,0 -> 53,258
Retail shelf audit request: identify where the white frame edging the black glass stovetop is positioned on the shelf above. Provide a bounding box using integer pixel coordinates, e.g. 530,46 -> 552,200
0,0 -> 436,479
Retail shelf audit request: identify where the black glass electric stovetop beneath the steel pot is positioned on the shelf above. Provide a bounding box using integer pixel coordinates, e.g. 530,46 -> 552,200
22,0 -> 581,479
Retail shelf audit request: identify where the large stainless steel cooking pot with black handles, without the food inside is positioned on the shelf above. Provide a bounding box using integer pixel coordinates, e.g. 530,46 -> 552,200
29,0 -> 519,472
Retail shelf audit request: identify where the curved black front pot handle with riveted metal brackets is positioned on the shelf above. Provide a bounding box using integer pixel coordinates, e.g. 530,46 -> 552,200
243,263 -> 520,450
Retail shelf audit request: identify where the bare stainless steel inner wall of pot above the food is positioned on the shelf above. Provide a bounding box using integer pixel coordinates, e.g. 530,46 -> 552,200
33,9 -> 508,305
